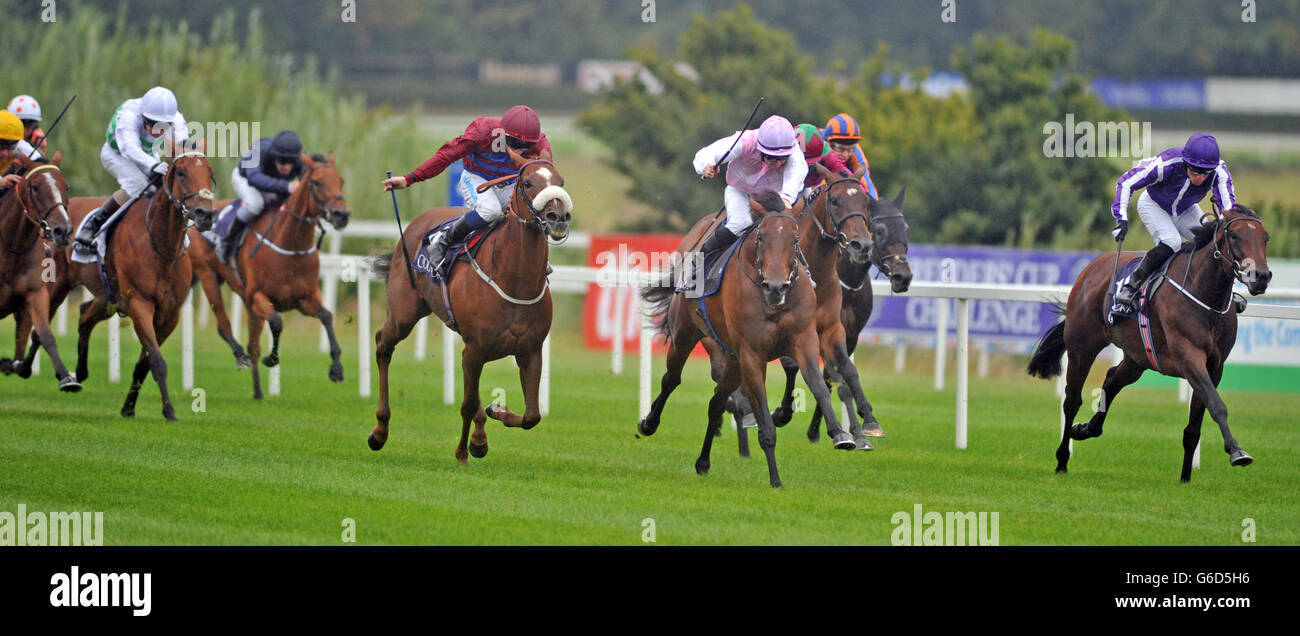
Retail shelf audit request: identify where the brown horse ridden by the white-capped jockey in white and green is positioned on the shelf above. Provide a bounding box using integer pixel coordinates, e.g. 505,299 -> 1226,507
55,143 -> 213,421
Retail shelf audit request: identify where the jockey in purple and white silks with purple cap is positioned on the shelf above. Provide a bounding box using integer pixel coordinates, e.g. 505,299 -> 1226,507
1110,133 -> 1236,312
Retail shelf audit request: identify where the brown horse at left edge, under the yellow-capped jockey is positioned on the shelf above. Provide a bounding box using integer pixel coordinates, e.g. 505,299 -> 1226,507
0,152 -> 81,393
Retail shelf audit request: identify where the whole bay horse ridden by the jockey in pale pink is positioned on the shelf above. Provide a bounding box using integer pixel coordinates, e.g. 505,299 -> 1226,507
637,190 -> 857,488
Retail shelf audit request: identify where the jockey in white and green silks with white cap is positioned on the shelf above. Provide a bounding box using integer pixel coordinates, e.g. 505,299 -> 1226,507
77,86 -> 190,251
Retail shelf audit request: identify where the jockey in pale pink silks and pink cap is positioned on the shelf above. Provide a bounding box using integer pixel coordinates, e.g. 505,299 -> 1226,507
693,114 -> 809,254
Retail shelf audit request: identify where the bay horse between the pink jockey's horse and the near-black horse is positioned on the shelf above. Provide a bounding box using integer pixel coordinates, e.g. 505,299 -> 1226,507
697,178 -> 874,457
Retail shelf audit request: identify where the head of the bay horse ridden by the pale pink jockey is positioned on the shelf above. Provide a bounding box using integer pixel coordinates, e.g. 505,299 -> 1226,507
749,190 -> 803,308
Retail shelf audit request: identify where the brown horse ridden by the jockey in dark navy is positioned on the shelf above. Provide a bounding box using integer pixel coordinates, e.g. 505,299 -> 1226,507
190,152 -> 351,399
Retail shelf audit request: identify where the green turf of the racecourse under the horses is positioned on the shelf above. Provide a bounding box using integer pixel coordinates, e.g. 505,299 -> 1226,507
0,299 -> 1300,545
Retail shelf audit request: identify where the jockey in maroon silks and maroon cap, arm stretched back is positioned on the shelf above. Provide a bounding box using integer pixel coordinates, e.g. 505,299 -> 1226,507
384,105 -> 551,268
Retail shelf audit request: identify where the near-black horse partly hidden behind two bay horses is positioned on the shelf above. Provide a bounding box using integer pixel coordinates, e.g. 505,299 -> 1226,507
772,187 -> 911,442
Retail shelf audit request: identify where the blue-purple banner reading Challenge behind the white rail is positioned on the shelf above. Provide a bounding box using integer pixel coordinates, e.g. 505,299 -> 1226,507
863,245 -> 1097,346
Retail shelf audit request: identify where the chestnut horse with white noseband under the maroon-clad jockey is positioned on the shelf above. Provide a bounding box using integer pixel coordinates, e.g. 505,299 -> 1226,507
369,151 -> 573,466
